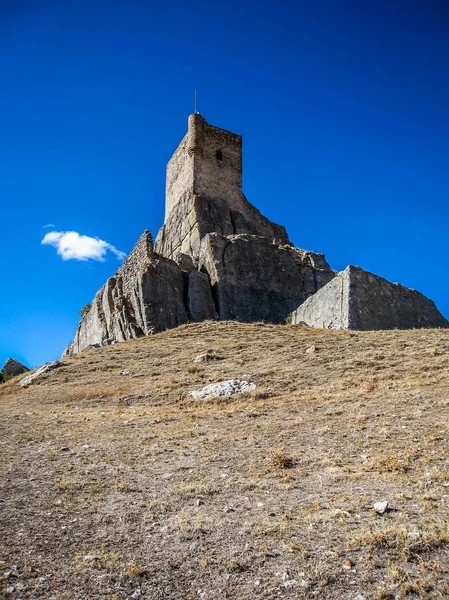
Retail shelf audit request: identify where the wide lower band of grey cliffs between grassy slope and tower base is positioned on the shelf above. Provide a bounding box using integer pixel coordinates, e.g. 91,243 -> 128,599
64,231 -> 334,356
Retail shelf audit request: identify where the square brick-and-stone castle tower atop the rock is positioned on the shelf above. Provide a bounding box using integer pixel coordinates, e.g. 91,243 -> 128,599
165,114 -> 245,222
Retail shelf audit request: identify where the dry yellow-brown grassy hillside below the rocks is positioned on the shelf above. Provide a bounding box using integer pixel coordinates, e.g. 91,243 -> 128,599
0,322 -> 449,600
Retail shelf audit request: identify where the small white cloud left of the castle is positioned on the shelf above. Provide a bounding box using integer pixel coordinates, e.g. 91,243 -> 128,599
41,231 -> 126,262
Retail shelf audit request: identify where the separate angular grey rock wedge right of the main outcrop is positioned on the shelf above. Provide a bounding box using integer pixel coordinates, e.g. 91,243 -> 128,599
292,266 -> 449,330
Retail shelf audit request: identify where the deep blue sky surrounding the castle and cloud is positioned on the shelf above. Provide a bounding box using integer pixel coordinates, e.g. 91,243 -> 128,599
0,0 -> 449,366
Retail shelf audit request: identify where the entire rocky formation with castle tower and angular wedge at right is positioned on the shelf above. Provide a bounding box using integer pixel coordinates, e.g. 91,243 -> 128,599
64,114 -> 447,355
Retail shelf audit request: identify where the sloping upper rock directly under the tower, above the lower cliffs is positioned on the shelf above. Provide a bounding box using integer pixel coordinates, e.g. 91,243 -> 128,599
155,191 -> 289,259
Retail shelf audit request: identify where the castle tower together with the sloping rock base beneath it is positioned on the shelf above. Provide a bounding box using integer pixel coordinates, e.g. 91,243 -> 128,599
155,113 -> 289,259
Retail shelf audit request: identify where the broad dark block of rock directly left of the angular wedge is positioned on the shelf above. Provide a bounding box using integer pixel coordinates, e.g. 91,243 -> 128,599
198,233 -> 334,323
